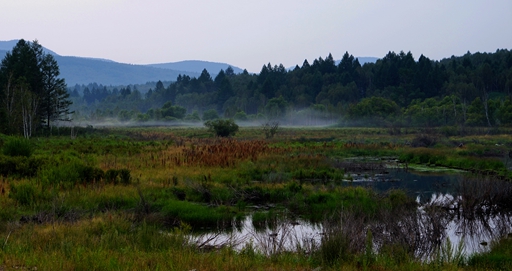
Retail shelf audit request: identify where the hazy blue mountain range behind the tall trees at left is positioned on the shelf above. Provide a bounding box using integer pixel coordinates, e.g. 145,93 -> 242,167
0,40 -> 242,86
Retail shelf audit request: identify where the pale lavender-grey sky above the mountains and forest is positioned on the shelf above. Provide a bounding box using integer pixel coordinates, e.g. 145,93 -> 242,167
0,0 -> 512,72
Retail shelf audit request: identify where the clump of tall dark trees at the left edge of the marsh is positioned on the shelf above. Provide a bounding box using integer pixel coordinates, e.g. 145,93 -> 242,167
0,40 -> 71,138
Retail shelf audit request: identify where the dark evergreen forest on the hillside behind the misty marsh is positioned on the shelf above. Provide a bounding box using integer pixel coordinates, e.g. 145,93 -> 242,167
70,49 -> 512,126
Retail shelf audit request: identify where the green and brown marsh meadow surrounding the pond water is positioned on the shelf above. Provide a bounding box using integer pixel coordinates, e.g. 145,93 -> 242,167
0,127 -> 512,270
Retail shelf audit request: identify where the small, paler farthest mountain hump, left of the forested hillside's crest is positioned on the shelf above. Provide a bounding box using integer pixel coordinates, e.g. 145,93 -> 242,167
146,60 -> 243,76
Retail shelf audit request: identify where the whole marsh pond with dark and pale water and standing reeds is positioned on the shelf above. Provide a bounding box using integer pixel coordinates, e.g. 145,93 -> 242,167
192,170 -> 512,258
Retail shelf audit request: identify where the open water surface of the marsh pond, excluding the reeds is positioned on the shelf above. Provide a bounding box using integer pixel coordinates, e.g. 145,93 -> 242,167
191,170 -> 512,260
